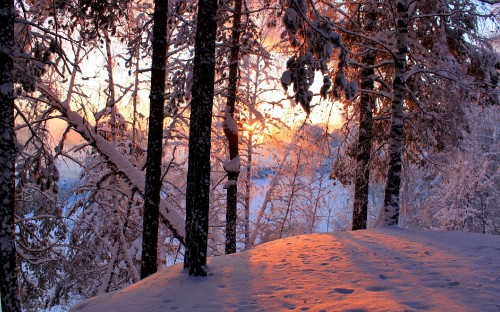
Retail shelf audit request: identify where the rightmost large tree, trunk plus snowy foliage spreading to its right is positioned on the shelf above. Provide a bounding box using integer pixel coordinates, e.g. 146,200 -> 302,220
380,0 -> 498,225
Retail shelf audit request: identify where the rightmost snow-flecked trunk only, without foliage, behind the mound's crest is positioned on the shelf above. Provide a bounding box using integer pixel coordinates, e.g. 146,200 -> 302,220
379,0 -> 408,226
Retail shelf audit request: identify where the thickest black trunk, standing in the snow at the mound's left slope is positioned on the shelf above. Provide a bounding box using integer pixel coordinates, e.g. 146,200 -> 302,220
185,0 -> 217,276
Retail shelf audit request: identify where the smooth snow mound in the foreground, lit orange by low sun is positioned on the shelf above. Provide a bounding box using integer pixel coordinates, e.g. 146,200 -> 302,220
72,228 -> 500,312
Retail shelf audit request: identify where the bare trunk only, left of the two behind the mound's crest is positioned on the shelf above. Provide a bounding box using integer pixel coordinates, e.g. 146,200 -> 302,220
352,4 -> 376,231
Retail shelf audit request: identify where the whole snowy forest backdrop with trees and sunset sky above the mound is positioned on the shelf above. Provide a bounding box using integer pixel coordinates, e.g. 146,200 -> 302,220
0,0 -> 500,311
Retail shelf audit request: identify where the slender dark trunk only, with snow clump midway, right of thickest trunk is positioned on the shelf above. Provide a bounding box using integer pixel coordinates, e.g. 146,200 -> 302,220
224,0 -> 243,254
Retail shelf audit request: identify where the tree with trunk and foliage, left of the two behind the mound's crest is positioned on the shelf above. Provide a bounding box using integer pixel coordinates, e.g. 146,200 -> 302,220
326,1 -> 391,230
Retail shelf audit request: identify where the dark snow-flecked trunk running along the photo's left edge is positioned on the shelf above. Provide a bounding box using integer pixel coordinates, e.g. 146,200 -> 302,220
0,0 -> 21,312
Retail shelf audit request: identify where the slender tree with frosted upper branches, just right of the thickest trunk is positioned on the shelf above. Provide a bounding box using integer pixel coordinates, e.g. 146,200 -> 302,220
217,0 -> 278,253
